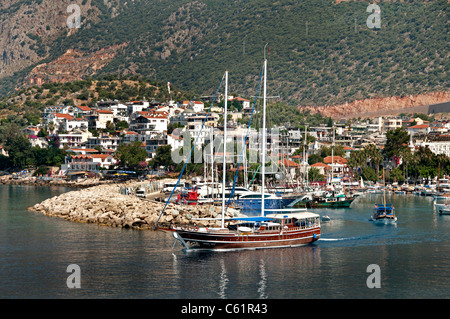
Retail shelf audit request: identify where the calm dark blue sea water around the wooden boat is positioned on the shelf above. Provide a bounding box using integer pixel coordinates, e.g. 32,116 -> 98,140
0,185 -> 450,299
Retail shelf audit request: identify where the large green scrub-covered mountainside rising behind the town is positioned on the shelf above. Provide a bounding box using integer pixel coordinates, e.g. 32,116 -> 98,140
0,0 -> 450,105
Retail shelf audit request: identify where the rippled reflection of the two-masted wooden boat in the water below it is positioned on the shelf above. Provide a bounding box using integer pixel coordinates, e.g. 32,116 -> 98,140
172,244 -> 321,299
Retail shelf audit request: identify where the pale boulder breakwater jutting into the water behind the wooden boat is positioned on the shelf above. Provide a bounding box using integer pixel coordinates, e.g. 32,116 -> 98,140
28,184 -> 246,229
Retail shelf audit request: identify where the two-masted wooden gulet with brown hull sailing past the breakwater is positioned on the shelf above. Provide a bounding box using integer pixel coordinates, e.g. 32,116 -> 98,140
155,53 -> 321,251
